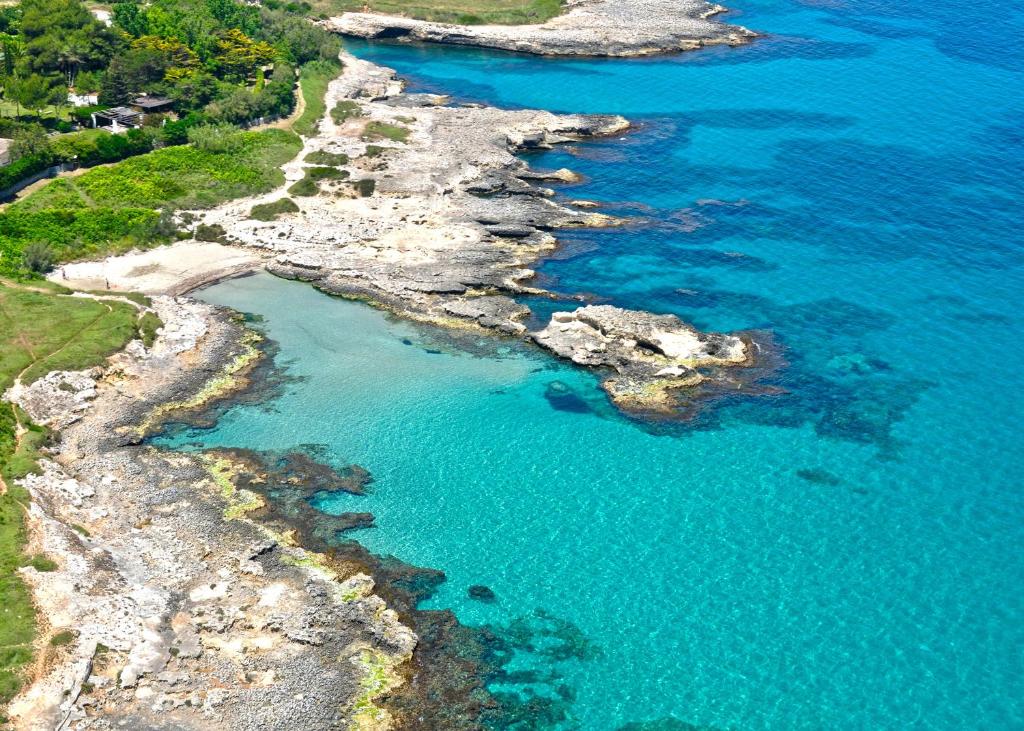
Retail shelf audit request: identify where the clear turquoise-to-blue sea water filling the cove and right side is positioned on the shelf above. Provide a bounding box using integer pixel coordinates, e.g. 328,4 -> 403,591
155,0 -> 1024,731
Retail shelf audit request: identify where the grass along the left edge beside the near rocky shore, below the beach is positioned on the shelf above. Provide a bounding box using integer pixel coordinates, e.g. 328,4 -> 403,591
0,282 -> 153,718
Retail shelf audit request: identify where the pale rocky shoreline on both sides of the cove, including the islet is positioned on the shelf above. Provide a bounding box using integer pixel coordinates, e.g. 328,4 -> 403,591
6,32 -> 770,729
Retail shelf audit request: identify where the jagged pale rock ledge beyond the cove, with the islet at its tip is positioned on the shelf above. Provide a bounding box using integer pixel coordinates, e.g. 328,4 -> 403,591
197,56 -> 761,415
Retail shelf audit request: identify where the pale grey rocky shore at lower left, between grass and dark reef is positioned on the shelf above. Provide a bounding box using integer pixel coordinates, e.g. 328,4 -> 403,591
8,297 -> 416,731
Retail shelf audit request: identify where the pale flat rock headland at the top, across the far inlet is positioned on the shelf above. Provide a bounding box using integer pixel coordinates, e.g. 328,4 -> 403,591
324,0 -> 757,56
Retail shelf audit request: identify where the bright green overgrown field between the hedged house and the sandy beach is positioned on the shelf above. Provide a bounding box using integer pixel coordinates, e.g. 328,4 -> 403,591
0,129 -> 302,275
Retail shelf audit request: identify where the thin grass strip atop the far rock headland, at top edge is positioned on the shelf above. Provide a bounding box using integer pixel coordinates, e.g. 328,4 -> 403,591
313,0 -> 562,26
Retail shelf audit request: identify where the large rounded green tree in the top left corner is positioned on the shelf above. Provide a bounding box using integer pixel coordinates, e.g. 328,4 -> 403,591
20,0 -> 117,86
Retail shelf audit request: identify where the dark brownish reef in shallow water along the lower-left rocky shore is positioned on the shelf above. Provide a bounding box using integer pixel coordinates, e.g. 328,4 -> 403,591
199,449 -> 600,731
